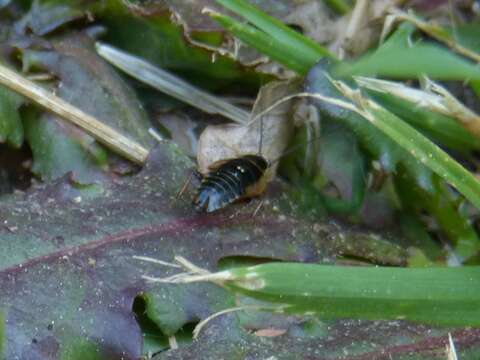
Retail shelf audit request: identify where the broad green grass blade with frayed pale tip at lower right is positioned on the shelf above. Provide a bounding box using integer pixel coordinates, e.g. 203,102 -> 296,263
224,263 -> 480,326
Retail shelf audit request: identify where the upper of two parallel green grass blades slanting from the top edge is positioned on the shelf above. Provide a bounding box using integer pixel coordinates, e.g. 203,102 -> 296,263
215,0 -> 334,61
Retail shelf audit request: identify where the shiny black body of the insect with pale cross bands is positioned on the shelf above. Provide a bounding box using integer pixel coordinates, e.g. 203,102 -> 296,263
193,155 -> 268,212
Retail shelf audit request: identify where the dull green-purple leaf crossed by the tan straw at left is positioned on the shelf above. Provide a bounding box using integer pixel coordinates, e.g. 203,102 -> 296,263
17,35 -> 153,183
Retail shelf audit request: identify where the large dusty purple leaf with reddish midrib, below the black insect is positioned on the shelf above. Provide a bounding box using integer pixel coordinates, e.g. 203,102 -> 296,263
0,143 -> 390,359
